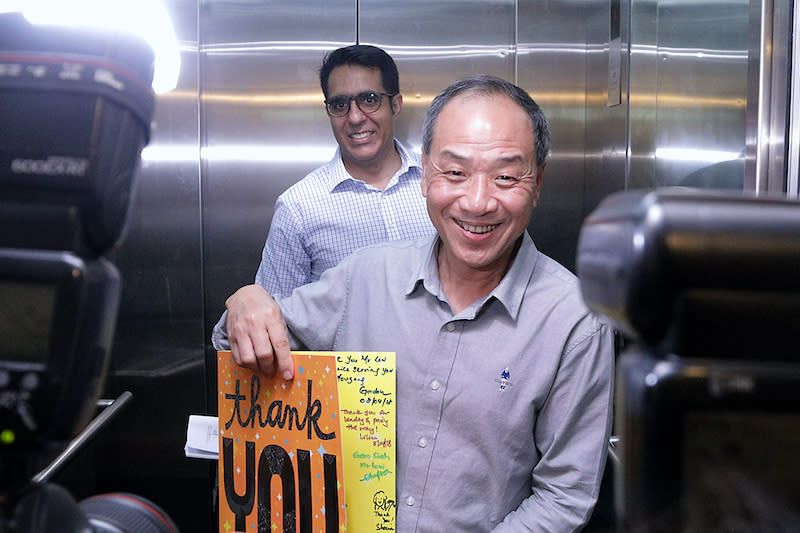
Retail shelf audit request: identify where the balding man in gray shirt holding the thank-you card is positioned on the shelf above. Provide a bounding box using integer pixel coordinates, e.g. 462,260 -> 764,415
216,77 -> 613,533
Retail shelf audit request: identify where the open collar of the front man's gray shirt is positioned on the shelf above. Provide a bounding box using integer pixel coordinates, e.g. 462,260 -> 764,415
405,231 -> 539,320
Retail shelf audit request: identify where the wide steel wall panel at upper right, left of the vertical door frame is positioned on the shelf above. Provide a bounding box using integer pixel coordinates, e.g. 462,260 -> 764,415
629,0 -> 751,189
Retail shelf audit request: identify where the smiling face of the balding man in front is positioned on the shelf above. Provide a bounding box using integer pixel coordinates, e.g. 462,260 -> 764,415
422,94 -> 544,276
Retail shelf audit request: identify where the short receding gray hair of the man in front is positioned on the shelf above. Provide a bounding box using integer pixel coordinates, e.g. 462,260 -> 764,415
422,76 -> 550,167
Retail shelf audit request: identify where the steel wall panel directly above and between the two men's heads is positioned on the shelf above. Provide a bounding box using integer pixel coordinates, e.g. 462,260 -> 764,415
358,0 -> 516,151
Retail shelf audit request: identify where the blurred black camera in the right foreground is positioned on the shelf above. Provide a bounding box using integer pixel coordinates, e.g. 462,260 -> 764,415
577,188 -> 800,532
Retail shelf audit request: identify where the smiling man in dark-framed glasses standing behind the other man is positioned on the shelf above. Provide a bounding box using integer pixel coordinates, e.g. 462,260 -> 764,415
212,45 -> 434,349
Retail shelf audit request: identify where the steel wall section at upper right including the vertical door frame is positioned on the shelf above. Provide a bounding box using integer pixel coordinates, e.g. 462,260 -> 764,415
628,0 -> 791,193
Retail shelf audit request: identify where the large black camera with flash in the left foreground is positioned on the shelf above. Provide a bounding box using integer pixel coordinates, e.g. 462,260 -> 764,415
0,12 -> 177,533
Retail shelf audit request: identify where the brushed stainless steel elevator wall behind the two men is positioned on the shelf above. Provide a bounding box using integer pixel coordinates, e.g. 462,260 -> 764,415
64,0 -> 792,531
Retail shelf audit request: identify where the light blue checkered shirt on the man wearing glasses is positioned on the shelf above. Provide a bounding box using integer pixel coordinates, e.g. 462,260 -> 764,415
255,140 -> 435,295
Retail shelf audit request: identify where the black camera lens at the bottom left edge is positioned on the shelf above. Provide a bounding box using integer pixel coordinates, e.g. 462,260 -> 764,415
80,493 -> 178,533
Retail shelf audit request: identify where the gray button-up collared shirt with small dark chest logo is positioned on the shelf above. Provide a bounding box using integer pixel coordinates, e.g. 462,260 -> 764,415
279,233 -> 614,533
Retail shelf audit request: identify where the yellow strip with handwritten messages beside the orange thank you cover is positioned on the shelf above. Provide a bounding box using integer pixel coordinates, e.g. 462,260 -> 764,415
336,352 -> 397,532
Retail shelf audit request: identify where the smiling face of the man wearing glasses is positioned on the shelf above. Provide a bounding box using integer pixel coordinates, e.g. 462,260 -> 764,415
328,65 -> 402,170
